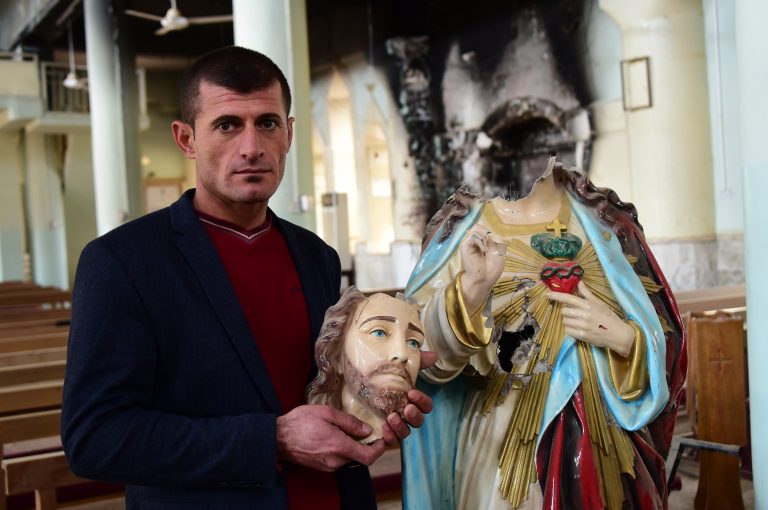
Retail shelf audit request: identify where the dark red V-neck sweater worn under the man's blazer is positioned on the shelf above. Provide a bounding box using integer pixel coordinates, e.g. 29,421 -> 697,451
198,211 -> 340,510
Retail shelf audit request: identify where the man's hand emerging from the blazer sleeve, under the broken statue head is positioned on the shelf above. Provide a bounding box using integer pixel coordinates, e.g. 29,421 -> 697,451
277,405 -> 386,471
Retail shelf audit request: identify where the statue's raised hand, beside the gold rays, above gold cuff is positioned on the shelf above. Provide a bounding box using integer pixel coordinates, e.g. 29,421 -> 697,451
461,225 -> 507,315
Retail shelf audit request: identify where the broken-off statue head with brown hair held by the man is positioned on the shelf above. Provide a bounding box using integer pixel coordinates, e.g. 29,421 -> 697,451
307,286 -> 424,443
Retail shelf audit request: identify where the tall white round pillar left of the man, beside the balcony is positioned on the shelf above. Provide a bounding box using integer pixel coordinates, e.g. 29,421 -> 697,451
84,0 -> 143,234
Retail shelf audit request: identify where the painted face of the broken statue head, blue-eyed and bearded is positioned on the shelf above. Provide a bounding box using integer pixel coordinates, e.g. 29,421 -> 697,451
342,294 -> 424,414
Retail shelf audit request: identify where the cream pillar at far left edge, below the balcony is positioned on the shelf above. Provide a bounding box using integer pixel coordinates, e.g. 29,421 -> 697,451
0,132 -> 24,281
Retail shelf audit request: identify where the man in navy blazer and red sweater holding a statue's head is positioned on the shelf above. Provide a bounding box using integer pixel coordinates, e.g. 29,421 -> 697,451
62,47 -> 431,510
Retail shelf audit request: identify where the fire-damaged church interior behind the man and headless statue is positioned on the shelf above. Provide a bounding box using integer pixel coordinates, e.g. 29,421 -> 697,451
0,0 -> 768,510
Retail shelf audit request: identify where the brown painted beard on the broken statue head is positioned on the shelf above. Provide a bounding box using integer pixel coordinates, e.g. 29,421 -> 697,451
344,356 -> 413,420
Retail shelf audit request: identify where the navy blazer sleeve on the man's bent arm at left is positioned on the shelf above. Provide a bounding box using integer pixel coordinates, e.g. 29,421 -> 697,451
62,239 -> 278,488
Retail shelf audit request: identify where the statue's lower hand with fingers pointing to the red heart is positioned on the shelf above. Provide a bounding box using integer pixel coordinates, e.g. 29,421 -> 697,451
547,282 -> 635,356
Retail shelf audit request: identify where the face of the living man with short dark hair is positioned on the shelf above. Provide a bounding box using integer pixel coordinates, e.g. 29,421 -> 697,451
174,81 -> 294,209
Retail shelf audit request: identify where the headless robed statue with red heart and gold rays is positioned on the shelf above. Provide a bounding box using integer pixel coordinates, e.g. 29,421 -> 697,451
403,159 -> 686,509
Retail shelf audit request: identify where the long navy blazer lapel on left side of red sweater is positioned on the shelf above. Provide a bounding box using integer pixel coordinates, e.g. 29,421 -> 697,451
170,190 -> 283,414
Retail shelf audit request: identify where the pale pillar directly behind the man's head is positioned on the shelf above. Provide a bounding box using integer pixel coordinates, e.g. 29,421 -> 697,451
232,0 -> 318,230
